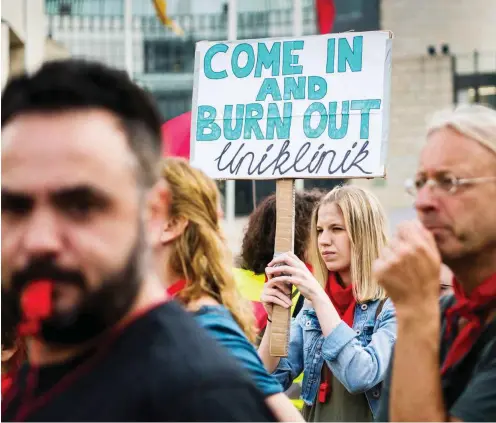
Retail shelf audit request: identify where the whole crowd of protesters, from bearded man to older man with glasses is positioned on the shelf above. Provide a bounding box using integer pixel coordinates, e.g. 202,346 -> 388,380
1,60 -> 496,422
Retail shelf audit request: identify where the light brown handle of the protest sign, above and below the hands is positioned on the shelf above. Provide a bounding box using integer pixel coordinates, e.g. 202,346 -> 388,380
270,179 -> 295,357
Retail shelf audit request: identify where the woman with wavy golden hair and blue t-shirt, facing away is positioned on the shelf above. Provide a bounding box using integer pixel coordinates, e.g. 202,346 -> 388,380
152,158 -> 303,421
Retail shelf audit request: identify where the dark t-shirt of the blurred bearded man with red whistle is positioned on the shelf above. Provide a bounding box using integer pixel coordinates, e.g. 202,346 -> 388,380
2,301 -> 276,422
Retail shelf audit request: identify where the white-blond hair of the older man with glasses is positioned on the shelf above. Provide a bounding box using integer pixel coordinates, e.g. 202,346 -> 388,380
427,104 -> 496,154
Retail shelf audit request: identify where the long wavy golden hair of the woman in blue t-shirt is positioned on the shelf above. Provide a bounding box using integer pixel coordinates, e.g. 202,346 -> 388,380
162,158 -> 256,342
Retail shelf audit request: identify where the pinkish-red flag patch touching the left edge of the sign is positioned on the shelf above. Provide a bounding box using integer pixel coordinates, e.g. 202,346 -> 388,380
162,112 -> 191,160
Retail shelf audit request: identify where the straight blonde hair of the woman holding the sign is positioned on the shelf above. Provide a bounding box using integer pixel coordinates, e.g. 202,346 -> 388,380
309,186 -> 388,303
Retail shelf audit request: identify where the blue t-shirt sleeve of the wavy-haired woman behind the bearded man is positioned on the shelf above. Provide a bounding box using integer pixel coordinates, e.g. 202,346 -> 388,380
195,305 -> 283,397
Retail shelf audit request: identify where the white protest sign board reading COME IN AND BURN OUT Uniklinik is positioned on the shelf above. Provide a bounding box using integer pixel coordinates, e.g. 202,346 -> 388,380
191,31 -> 391,179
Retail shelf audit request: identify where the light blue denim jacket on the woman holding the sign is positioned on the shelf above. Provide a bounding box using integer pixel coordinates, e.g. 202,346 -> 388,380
273,299 -> 397,416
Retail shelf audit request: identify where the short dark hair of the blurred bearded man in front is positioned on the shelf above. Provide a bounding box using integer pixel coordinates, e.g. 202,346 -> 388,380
2,59 -> 162,186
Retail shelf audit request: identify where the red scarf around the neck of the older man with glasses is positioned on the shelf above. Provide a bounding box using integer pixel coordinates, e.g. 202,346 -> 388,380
441,273 -> 496,374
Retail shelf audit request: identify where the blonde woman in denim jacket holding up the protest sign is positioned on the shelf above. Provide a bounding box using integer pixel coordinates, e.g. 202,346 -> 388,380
259,186 -> 396,421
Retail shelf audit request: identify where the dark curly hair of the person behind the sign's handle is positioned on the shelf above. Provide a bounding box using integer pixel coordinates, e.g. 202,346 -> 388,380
241,189 -> 324,274
